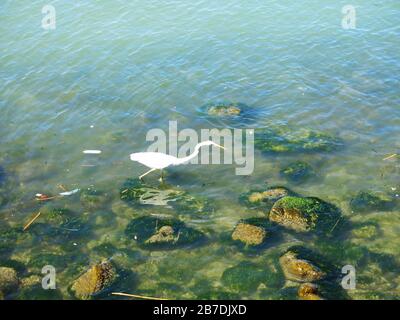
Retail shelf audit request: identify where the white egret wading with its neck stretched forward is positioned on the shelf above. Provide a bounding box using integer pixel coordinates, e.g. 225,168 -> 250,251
130,141 -> 225,181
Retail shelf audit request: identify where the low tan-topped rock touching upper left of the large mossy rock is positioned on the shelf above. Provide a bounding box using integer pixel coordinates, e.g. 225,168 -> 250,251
239,187 -> 293,209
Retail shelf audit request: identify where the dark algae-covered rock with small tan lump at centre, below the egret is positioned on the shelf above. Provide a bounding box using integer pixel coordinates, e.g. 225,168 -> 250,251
125,216 -> 204,249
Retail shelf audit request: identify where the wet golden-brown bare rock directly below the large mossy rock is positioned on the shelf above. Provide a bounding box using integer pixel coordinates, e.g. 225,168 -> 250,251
279,249 -> 326,282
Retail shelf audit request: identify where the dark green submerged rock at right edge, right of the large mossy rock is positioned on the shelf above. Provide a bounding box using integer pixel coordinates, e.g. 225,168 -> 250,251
350,191 -> 395,212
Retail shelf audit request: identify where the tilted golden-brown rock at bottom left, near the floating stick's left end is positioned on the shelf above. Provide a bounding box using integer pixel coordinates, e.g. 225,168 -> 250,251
71,261 -> 116,300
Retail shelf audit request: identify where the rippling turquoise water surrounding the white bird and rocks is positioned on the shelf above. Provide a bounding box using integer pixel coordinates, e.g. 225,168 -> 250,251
0,0 -> 400,299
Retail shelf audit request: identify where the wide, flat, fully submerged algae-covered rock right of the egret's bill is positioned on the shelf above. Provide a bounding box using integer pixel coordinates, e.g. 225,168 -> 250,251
254,128 -> 343,153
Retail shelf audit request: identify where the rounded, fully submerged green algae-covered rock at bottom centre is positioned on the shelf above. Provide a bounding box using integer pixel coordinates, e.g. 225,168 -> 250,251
221,262 -> 267,294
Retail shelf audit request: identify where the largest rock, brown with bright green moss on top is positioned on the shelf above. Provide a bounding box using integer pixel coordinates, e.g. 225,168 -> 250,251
269,197 -> 340,232
